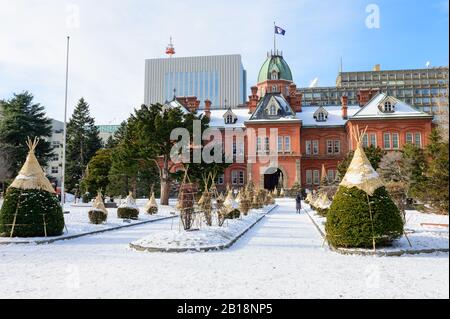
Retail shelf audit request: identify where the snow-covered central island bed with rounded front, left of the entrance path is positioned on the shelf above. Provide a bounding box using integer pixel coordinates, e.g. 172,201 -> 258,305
130,205 -> 277,252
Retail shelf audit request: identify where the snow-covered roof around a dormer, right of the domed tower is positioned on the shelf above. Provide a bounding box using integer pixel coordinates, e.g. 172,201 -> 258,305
297,105 -> 360,127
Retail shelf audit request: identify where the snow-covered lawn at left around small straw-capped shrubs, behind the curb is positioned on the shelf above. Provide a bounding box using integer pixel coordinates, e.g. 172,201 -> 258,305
0,199 -> 176,243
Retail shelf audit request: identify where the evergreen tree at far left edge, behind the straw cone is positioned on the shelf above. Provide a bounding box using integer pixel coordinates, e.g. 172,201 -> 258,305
0,92 -> 53,176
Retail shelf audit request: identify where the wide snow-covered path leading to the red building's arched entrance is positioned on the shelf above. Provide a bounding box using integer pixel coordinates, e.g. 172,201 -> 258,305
0,200 -> 449,298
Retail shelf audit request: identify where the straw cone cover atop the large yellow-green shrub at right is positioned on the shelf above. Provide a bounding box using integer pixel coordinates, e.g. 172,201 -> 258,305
339,126 -> 383,196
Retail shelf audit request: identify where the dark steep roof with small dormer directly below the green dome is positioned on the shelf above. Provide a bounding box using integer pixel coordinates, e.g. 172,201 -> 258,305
250,93 -> 295,121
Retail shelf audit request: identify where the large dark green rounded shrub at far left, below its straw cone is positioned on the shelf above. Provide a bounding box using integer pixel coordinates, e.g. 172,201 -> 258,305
0,188 -> 64,237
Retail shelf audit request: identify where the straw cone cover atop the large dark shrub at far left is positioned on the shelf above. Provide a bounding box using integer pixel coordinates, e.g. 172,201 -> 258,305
9,137 -> 55,194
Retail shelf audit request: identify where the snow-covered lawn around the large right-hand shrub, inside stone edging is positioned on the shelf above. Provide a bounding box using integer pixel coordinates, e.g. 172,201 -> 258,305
303,203 -> 449,252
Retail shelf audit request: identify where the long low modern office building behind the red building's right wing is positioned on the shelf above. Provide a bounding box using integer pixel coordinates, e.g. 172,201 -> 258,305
299,65 -> 448,113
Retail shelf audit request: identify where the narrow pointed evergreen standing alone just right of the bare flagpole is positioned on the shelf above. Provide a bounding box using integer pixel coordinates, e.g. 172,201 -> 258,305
65,98 -> 102,191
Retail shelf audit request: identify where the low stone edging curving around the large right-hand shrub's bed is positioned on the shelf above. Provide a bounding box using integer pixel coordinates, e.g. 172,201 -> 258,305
304,209 -> 449,257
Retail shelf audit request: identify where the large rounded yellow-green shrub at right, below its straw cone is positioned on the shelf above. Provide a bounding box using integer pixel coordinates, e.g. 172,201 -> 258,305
325,186 -> 403,248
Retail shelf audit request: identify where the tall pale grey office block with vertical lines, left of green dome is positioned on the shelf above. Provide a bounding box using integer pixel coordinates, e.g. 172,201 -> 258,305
144,54 -> 247,108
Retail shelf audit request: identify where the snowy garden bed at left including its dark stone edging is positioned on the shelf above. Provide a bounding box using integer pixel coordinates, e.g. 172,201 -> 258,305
0,199 -> 177,245
